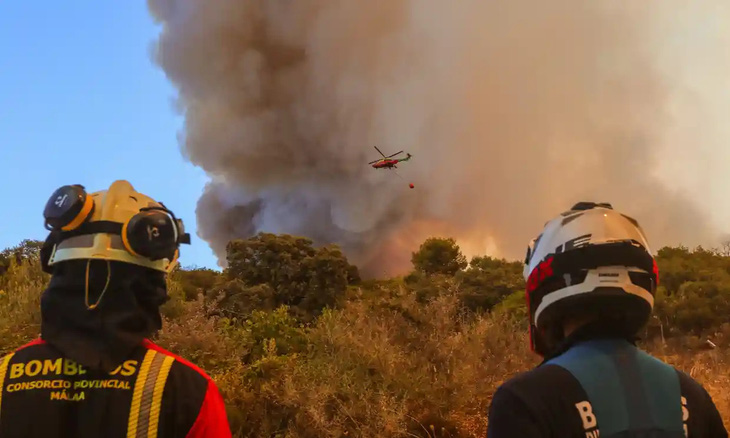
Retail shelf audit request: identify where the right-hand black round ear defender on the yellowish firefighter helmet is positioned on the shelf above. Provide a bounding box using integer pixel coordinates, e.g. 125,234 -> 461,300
122,207 -> 190,261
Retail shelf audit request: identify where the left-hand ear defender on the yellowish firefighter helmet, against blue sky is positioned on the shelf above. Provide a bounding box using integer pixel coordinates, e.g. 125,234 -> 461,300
43,184 -> 94,231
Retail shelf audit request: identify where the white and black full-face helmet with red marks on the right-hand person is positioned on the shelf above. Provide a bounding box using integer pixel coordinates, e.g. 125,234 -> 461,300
524,202 -> 659,355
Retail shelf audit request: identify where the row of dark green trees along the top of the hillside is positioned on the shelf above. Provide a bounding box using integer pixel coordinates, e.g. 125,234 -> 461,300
0,233 -> 730,336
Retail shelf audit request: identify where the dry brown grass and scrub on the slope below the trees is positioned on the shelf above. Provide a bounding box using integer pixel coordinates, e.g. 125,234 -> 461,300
0,265 -> 730,438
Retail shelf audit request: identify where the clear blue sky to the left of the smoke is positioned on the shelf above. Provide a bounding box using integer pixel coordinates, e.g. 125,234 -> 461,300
0,0 -> 217,268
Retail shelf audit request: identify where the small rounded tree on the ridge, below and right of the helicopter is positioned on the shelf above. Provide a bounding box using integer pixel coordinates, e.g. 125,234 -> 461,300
411,237 -> 467,276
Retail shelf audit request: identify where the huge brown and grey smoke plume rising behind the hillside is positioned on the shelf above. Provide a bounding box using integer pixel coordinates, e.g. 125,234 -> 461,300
149,0 -> 727,275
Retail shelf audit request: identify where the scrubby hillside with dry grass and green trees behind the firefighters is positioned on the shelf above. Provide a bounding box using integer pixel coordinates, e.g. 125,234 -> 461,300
0,234 -> 730,438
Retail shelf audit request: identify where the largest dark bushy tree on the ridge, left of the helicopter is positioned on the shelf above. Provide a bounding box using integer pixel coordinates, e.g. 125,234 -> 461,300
225,233 -> 359,319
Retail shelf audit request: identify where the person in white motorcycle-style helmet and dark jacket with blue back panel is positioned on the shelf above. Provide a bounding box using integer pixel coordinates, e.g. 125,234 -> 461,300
487,203 -> 728,438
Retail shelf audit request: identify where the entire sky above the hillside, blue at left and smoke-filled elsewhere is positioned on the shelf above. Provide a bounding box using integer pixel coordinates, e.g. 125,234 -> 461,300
0,0 -> 730,276
